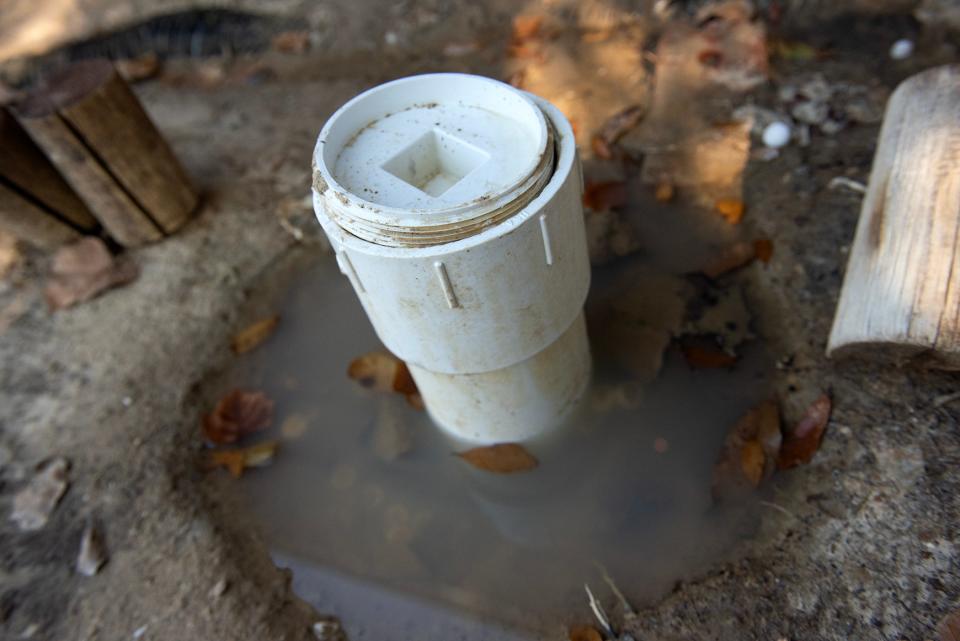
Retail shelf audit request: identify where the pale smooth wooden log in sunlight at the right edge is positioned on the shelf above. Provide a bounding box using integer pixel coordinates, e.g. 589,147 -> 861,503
827,65 -> 960,369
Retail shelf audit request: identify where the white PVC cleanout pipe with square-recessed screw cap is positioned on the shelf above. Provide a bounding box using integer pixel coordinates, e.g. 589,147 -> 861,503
313,73 -> 590,443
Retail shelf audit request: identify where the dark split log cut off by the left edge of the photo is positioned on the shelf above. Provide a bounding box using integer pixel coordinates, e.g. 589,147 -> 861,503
0,107 -> 99,249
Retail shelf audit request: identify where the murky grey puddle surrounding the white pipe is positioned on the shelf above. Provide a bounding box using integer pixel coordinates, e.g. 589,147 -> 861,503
239,191 -> 772,640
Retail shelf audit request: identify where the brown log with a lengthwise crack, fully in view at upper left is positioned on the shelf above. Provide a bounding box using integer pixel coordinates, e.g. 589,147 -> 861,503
15,60 -> 198,246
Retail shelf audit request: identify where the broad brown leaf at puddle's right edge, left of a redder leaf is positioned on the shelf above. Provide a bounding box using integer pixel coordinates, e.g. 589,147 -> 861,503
713,400 -> 783,499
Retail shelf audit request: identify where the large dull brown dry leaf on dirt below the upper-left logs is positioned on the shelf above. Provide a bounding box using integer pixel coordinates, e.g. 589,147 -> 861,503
44,236 -> 140,310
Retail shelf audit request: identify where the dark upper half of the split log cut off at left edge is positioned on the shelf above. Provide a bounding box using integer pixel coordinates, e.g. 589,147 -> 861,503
0,107 -> 99,235
